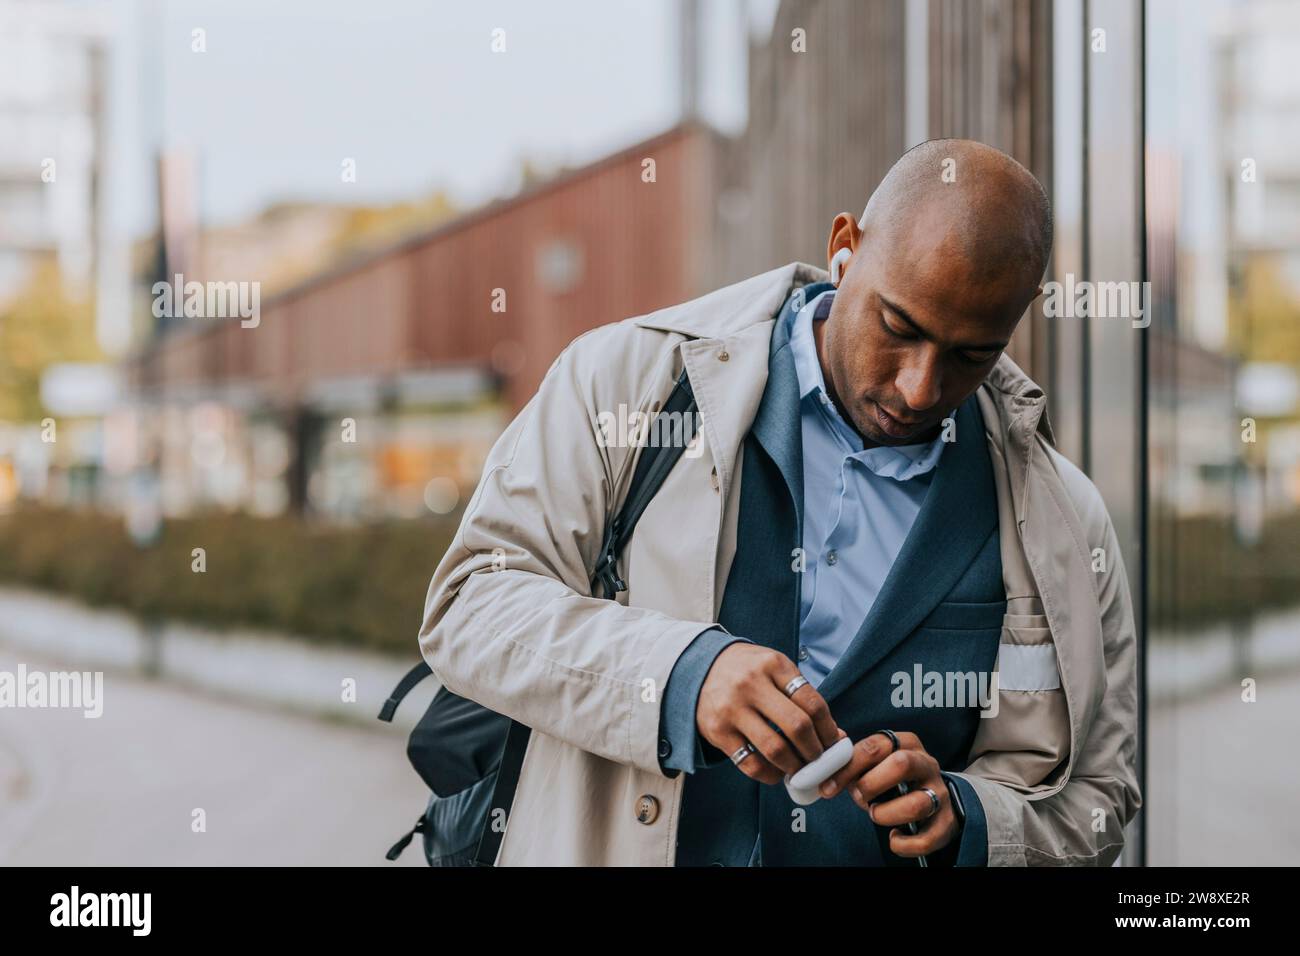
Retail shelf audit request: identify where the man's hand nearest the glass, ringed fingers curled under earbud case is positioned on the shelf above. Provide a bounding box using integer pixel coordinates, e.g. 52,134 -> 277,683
820,731 -> 959,857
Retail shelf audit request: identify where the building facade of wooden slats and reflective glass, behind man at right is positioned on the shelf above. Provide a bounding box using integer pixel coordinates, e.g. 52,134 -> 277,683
733,0 -> 1300,865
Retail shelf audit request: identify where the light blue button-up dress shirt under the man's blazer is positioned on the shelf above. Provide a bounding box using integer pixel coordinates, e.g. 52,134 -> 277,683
790,291 -> 945,687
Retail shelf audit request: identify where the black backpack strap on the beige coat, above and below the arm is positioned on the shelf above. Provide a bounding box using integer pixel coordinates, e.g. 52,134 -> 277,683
475,369 -> 696,866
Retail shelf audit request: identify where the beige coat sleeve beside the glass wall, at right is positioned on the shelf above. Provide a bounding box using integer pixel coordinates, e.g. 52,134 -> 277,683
952,476 -> 1141,866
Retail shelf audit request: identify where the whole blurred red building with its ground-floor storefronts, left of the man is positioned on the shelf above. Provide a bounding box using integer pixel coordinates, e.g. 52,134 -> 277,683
114,122 -> 722,518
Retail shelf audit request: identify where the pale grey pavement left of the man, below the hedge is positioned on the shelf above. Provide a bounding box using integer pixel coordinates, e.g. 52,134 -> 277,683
0,645 -> 428,866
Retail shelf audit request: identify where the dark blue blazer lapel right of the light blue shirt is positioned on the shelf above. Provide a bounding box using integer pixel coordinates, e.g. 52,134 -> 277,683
818,395 -> 997,701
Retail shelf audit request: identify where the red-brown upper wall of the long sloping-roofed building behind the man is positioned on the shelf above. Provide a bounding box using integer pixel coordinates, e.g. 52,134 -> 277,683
134,124 -> 722,408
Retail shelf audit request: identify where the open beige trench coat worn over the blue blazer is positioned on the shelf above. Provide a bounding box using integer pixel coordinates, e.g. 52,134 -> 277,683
420,263 -> 1141,866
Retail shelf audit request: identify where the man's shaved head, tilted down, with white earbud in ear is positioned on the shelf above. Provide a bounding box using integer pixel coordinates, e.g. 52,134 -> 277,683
813,139 -> 1052,445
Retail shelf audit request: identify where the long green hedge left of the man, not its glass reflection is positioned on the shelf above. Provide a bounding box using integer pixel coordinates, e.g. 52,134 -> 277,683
0,509 -> 458,658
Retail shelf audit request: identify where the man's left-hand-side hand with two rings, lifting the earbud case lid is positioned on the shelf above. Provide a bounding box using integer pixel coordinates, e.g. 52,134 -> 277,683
696,643 -> 844,783
